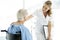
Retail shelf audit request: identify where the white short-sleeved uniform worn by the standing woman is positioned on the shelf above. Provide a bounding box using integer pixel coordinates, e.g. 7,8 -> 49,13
32,10 -> 51,40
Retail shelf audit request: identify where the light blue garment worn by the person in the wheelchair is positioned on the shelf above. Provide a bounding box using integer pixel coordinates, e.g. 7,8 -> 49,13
8,24 -> 32,40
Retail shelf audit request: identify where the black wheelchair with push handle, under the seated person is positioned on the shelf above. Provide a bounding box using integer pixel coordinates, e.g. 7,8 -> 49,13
1,30 -> 22,40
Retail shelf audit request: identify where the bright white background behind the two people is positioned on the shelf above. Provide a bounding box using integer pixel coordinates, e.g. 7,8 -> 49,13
0,0 -> 60,40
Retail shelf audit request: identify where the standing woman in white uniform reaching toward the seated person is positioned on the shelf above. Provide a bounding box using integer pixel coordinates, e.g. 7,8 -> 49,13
25,1 -> 52,40
